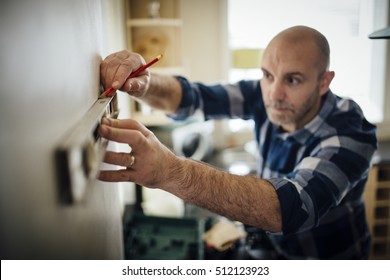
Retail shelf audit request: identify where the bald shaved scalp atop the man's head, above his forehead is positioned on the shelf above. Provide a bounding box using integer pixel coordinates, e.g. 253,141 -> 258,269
266,26 -> 330,72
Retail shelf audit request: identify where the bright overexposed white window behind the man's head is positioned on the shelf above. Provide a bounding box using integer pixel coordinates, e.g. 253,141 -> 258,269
228,0 -> 389,123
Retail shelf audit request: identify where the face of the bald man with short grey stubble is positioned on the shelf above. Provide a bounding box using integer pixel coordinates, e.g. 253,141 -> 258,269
261,40 -> 329,132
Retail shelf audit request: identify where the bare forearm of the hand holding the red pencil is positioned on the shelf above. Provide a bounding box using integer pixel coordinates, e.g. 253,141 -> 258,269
140,74 -> 182,113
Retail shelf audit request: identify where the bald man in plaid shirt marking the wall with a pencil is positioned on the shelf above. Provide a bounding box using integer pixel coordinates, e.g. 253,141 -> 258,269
99,26 -> 376,259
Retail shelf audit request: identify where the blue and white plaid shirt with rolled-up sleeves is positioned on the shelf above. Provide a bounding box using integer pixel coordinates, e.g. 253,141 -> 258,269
173,77 -> 377,259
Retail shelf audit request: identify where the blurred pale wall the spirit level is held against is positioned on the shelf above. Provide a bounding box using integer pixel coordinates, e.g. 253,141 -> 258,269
0,0 -> 123,259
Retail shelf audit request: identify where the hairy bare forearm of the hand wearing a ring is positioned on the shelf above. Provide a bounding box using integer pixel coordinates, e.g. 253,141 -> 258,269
160,159 -> 281,232
